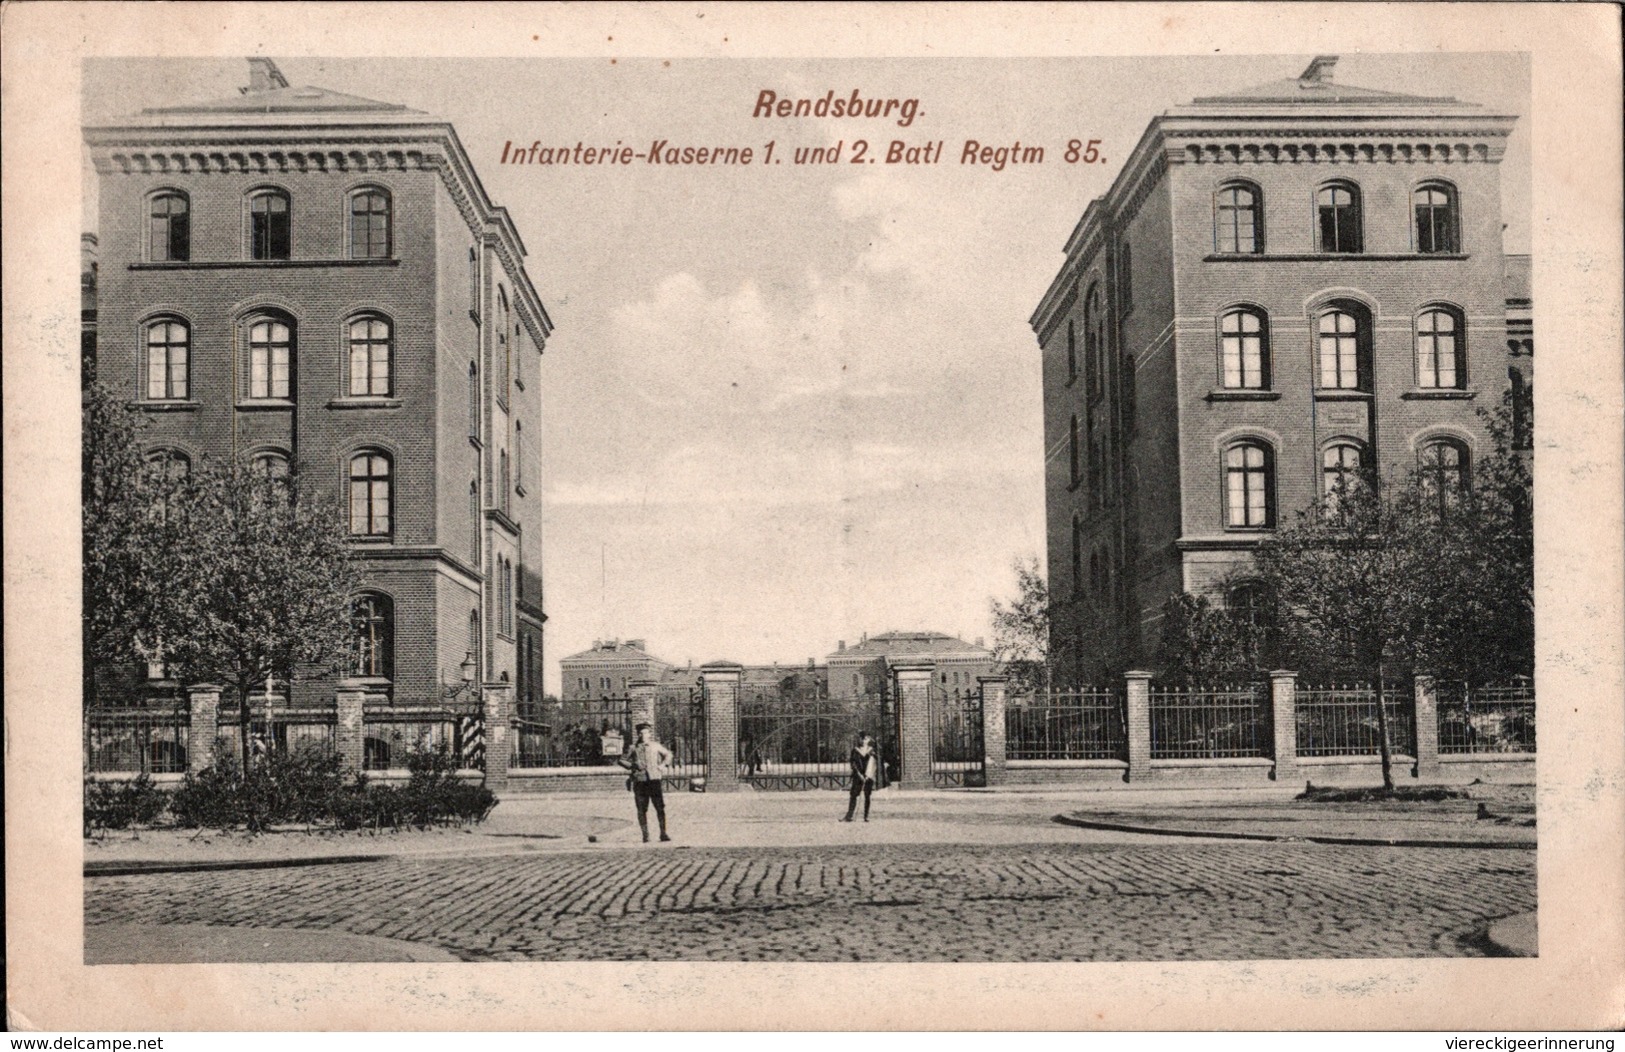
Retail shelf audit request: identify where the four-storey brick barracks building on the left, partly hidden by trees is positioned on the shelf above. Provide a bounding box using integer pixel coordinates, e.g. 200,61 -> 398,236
85,59 -> 551,780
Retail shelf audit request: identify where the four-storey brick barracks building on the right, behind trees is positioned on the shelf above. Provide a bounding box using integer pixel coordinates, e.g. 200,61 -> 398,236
1032,57 -> 1532,675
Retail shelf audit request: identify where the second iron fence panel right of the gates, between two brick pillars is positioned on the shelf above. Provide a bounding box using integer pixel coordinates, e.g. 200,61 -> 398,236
1151,683 -> 1274,759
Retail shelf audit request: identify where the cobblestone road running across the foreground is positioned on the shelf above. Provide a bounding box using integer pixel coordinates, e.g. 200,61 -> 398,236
85,841 -> 1536,961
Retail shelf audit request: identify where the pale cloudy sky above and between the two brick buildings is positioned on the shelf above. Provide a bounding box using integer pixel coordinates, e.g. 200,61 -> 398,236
85,54 -> 1529,688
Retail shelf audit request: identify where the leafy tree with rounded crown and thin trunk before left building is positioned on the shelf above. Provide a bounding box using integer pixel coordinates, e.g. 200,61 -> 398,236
164,463 -> 361,763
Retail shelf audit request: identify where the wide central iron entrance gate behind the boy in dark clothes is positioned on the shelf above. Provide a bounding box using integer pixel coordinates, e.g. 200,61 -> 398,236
739,691 -> 899,789
